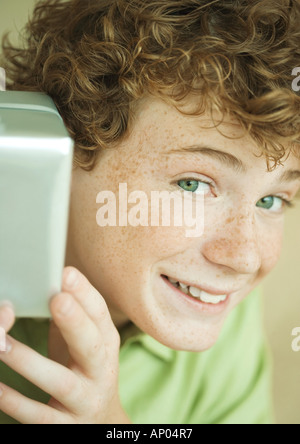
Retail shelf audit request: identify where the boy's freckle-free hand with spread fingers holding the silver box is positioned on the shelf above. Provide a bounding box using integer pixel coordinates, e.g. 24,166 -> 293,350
0,267 -> 130,424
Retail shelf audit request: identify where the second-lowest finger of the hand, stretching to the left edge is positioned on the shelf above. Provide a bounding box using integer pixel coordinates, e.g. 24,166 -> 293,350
0,336 -> 85,413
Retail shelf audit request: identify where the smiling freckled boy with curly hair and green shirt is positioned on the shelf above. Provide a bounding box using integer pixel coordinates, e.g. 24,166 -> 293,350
0,0 -> 300,424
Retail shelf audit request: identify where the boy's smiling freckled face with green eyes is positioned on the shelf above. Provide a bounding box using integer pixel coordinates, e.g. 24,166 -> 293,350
66,99 -> 300,351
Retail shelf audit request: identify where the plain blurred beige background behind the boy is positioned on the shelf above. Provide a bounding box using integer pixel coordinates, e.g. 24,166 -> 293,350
0,0 -> 300,424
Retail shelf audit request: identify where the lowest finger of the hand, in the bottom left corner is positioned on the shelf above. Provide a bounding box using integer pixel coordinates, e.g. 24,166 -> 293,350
0,383 -> 71,424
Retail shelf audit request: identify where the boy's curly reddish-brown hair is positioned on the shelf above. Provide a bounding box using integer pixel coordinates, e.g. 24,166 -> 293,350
2,0 -> 300,170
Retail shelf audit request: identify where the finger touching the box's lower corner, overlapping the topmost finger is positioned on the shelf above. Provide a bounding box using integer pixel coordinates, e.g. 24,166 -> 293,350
50,293 -> 110,378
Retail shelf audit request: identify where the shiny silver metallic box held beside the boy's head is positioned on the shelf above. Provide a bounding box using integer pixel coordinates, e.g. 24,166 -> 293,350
0,91 -> 73,318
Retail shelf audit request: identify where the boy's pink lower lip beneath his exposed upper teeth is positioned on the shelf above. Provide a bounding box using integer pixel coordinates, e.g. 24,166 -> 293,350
161,275 -> 232,316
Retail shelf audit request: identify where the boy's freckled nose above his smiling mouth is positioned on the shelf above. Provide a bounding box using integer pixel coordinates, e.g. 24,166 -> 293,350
202,209 -> 262,274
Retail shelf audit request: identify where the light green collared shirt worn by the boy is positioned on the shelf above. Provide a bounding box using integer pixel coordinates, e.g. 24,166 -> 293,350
0,290 -> 273,424
